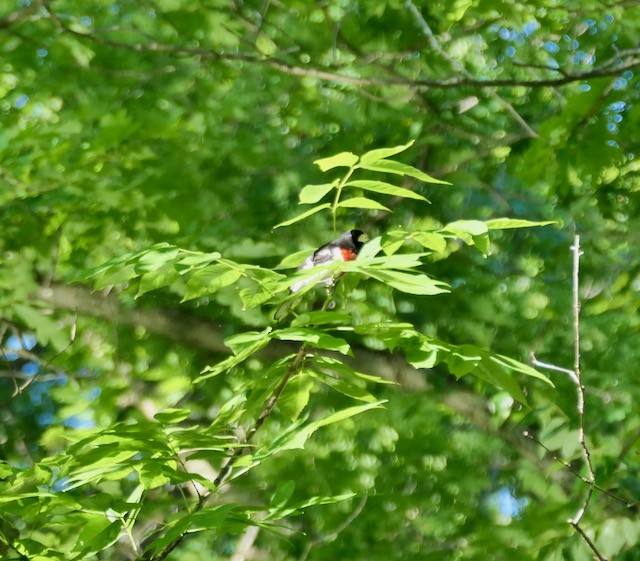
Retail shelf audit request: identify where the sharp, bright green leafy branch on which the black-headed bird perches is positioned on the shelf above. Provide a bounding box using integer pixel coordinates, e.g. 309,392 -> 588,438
2,142 -> 548,561
